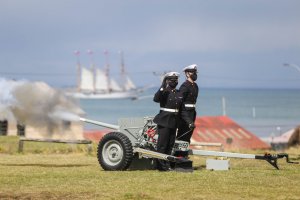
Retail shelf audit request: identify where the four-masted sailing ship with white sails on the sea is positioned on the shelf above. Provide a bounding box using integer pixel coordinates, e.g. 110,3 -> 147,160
67,52 -> 139,99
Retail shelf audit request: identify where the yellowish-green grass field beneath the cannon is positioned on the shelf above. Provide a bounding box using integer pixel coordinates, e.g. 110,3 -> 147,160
0,137 -> 300,199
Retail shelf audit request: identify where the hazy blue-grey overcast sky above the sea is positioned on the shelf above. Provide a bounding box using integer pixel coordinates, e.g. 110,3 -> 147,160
0,0 -> 300,88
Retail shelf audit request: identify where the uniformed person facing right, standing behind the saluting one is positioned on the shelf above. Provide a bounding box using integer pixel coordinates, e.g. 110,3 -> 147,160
177,64 -> 199,143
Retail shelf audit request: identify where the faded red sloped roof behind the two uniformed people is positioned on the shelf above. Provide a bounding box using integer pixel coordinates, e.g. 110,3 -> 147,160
191,116 -> 270,150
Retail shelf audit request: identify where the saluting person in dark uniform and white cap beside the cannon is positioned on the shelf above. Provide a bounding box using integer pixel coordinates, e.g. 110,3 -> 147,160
153,72 -> 182,171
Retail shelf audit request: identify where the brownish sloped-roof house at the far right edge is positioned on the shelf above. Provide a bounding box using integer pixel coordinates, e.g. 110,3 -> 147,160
270,126 -> 300,150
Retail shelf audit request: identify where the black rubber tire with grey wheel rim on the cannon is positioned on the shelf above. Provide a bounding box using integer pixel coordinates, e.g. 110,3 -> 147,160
97,132 -> 133,171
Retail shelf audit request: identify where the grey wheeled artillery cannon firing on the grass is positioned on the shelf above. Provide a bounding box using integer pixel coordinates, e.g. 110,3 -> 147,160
80,117 -> 298,171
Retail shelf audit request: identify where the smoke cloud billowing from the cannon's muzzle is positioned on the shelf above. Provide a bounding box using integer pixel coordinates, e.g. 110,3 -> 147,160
0,79 -> 84,129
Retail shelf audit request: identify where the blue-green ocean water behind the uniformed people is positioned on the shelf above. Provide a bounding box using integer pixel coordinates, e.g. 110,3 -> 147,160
79,88 -> 300,137
